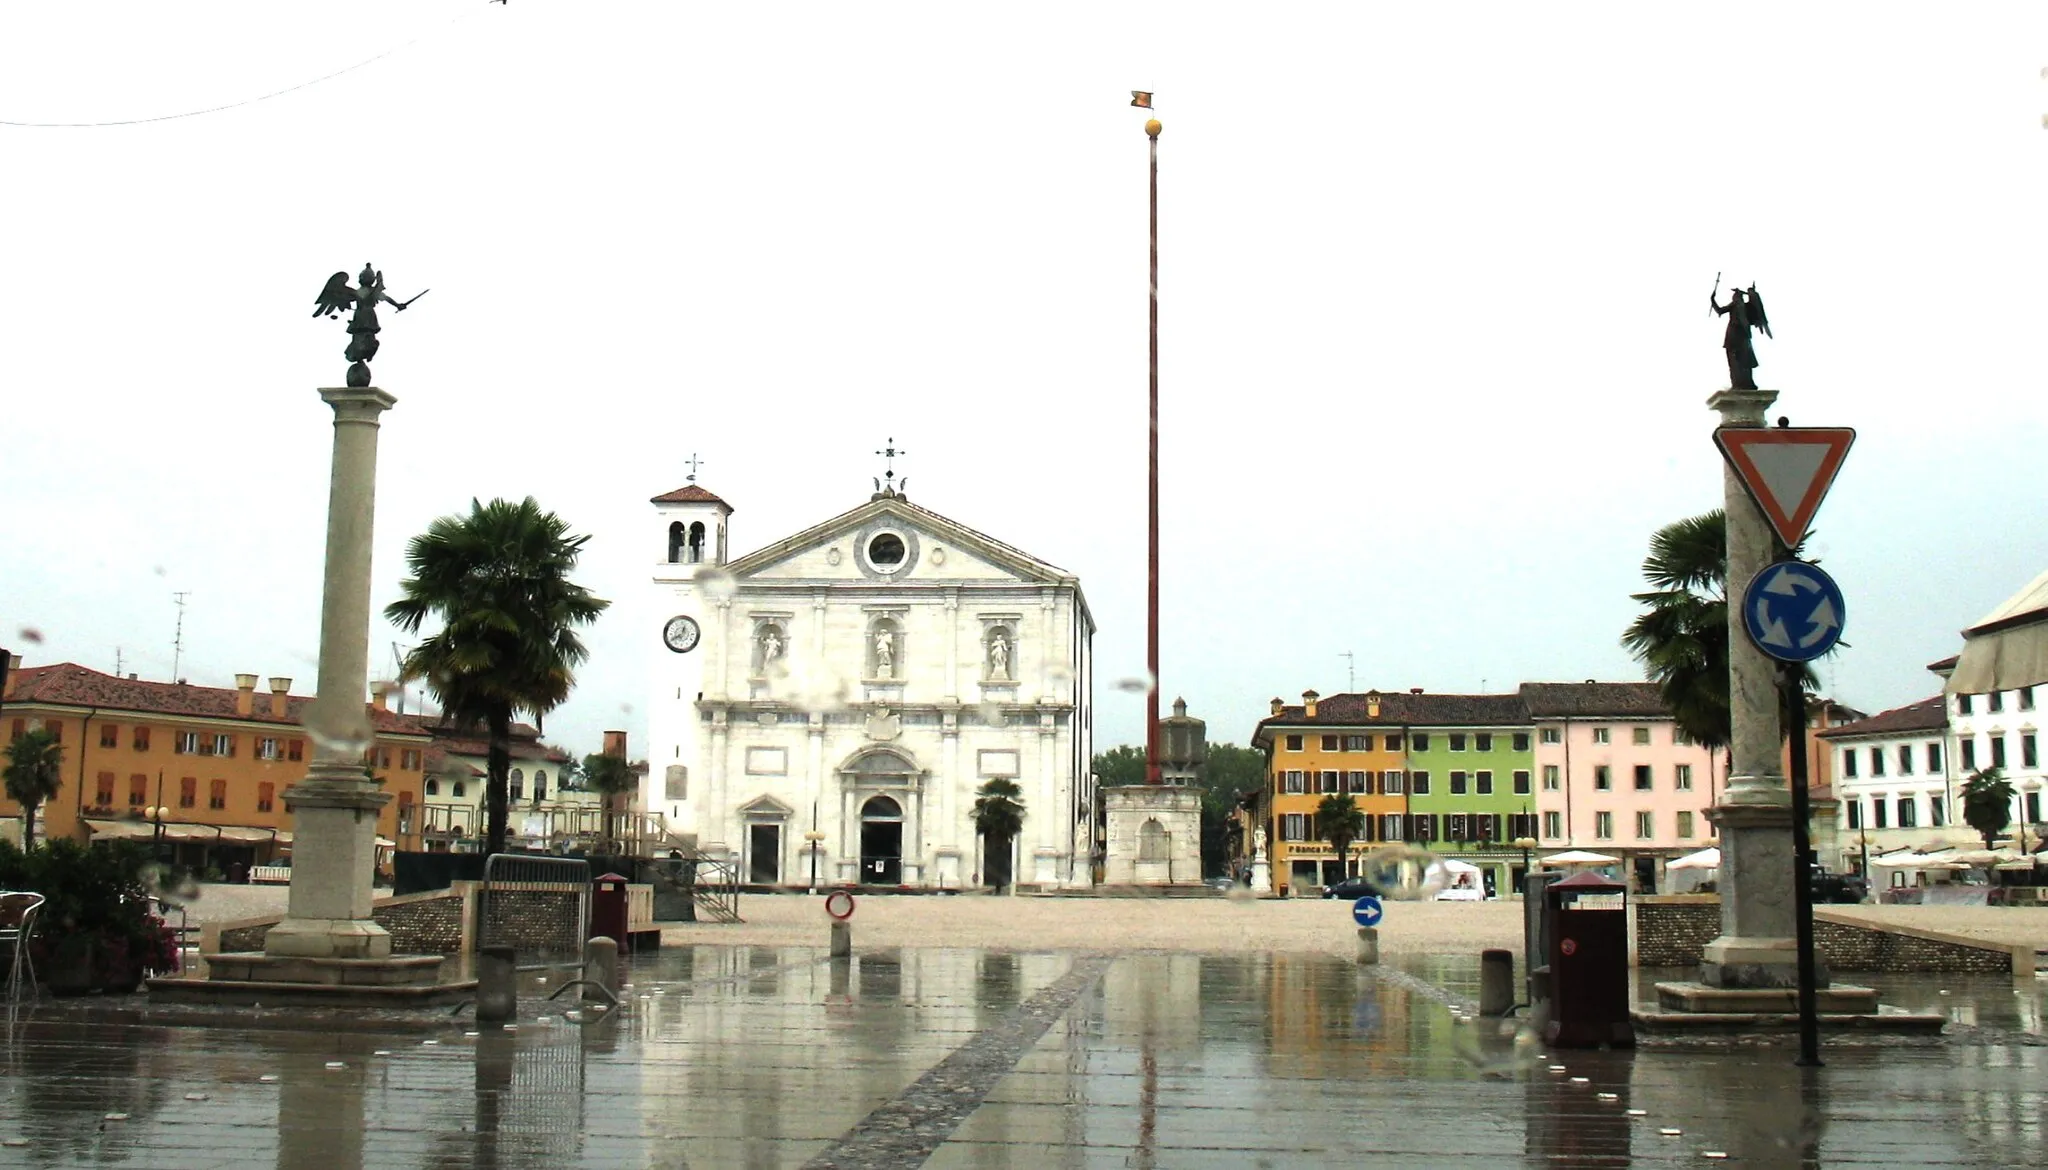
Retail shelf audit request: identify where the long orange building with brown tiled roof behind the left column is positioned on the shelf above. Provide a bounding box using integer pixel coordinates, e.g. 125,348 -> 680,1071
0,662 -> 432,873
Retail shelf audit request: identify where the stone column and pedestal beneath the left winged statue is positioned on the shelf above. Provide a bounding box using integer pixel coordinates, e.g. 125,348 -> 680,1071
264,387 -> 397,959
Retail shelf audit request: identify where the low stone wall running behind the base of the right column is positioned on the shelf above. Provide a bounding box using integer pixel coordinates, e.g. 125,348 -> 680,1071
1628,893 -> 2034,975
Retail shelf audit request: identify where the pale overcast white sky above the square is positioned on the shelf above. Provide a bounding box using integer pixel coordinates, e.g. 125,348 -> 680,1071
0,0 -> 2048,754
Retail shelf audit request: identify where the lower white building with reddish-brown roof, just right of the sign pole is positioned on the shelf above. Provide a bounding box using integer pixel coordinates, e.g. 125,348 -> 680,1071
1815,695 -> 1974,883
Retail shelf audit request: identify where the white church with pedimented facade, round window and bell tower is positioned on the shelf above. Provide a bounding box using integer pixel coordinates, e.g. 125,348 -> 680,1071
641,475 -> 1096,889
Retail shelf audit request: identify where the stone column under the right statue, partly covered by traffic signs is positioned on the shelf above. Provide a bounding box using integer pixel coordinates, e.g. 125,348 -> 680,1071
1700,389 -> 1798,988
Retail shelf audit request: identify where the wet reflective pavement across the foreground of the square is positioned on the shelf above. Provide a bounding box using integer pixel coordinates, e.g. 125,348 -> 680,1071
0,947 -> 2048,1170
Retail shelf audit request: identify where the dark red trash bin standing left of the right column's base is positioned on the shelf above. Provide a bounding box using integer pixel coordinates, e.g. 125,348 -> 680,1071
1544,873 -> 1636,1049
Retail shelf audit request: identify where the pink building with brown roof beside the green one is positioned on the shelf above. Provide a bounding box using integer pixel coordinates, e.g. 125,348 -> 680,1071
1522,680 -> 1722,891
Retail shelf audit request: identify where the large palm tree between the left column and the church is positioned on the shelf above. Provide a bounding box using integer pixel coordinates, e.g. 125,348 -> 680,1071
385,496 -> 610,852
